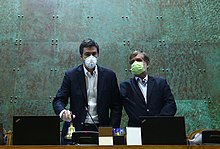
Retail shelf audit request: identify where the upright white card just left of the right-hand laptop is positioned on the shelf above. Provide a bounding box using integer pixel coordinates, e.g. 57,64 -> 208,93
126,127 -> 142,145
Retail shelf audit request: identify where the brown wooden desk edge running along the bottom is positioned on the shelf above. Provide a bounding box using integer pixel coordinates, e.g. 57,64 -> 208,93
0,145 -> 220,149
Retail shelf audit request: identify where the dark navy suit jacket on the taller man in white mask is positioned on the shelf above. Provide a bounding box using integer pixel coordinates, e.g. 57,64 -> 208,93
53,65 -> 122,136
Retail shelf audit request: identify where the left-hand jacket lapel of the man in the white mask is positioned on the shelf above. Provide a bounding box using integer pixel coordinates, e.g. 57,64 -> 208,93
77,65 -> 88,103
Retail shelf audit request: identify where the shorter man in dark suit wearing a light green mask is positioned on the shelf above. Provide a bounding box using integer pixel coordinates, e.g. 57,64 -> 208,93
120,50 -> 176,126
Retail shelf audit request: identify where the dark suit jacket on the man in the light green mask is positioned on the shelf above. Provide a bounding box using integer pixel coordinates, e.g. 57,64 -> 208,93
120,76 -> 176,126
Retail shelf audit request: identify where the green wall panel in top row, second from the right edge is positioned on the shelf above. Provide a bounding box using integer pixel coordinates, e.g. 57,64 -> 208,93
159,0 -> 195,44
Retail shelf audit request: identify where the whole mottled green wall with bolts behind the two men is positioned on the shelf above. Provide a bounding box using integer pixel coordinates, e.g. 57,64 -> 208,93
0,0 -> 220,134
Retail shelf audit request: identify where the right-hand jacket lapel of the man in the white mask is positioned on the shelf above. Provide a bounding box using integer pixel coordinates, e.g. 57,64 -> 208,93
97,66 -> 105,102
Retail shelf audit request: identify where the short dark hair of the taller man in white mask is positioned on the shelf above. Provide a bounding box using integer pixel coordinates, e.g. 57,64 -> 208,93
79,38 -> 99,55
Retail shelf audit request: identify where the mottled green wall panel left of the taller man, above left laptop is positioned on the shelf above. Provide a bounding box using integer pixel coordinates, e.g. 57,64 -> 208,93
15,42 -> 55,100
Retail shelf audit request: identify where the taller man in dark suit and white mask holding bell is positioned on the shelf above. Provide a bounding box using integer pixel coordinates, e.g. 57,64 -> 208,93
53,39 -> 122,144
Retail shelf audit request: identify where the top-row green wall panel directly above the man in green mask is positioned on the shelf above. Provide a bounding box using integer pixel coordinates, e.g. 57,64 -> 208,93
126,0 -> 161,42
